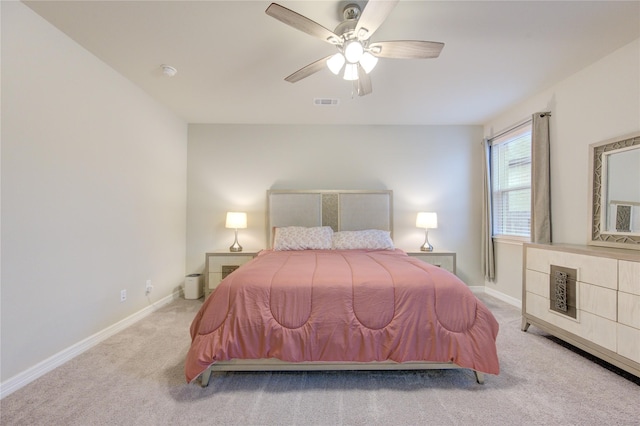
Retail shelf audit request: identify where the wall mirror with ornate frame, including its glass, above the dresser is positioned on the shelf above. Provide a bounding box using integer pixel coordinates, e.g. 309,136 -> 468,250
589,133 -> 640,250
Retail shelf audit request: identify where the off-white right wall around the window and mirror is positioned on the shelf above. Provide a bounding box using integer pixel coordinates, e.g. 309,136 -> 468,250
484,39 -> 640,300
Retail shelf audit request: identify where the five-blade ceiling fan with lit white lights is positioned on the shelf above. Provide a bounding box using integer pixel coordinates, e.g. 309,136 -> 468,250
265,0 -> 444,96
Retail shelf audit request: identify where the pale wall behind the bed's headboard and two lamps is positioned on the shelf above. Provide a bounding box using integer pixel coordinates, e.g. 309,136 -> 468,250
187,124 -> 483,286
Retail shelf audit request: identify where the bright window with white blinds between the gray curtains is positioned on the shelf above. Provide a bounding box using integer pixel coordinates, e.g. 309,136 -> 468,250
491,122 -> 531,239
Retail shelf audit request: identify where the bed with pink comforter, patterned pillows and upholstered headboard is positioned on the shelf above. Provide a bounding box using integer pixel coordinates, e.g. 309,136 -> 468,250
185,190 -> 499,386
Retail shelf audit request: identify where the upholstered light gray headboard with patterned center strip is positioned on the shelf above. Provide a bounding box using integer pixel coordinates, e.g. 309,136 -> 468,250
266,189 -> 393,247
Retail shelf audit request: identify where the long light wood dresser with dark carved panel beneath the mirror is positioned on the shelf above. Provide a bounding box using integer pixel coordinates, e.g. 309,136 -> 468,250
522,244 -> 640,377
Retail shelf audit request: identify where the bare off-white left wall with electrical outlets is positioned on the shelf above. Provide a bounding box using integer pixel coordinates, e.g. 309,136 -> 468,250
1,2 -> 187,382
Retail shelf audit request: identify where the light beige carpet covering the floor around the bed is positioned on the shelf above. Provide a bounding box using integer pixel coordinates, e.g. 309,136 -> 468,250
0,295 -> 640,425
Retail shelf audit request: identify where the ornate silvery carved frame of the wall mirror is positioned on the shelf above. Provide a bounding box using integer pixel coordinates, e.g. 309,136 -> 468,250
588,132 -> 640,250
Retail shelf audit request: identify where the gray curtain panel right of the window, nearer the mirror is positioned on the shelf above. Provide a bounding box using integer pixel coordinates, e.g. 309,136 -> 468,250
531,112 -> 551,243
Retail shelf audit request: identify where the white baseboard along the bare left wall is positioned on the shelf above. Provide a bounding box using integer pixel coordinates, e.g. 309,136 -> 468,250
0,290 -> 181,399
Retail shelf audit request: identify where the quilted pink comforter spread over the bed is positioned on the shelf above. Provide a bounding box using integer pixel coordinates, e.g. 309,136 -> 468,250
185,250 -> 499,382
